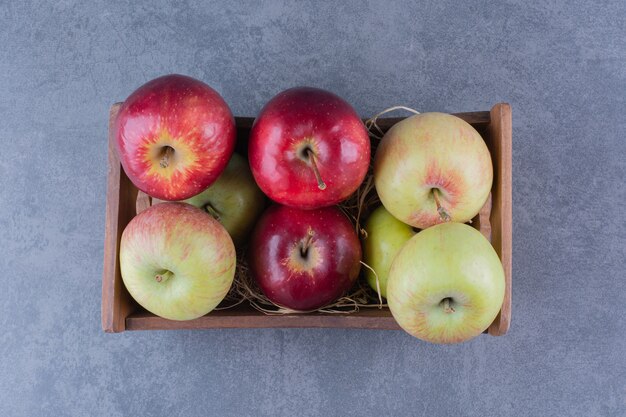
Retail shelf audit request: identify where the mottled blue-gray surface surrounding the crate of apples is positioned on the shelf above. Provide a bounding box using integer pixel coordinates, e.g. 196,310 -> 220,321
0,0 -> 626,417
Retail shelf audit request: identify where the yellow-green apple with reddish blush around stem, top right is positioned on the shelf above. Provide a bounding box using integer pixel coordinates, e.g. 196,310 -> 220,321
374,113 -> 493,229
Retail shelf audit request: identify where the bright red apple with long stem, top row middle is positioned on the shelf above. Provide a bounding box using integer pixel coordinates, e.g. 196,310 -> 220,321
248,87 -> 370,209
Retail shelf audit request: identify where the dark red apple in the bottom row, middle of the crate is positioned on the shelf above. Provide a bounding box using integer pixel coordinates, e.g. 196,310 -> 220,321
249,205 -> 361,311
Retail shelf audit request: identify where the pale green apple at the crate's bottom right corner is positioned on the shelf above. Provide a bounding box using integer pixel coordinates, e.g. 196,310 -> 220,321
387,223 -> 504,343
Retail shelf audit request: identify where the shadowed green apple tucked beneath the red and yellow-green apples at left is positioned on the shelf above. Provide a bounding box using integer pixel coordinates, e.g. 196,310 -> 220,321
152,153 -> 265,245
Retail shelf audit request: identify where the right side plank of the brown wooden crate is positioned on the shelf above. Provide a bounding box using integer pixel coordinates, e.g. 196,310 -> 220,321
488,103 -> 513,336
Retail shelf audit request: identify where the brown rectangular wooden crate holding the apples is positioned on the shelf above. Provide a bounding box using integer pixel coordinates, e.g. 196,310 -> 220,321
102,103 -> 512,336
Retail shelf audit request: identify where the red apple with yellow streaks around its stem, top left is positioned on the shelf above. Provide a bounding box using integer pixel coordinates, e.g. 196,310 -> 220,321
114,75 -> 236,201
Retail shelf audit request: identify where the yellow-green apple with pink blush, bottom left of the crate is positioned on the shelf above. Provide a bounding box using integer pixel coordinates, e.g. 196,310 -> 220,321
120,203 -> 236,320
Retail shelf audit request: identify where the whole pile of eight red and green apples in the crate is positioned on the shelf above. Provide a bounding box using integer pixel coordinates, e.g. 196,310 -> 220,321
114,75 -> 504,343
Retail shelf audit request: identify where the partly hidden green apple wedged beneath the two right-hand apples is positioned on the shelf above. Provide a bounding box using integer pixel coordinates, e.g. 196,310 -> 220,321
363,206 -> 415,298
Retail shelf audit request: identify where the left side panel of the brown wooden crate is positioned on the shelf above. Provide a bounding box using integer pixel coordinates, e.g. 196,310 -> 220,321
102,104 -> 137,333
